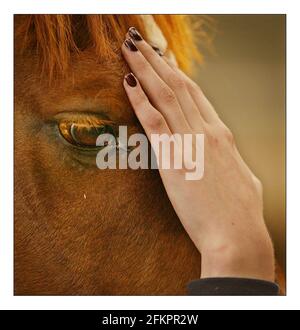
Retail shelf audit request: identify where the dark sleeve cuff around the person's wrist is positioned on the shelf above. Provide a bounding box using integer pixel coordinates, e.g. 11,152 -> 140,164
188,278 -> 279,296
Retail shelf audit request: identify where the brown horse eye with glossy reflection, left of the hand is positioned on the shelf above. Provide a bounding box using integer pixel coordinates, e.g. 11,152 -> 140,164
58,119 -> 115,148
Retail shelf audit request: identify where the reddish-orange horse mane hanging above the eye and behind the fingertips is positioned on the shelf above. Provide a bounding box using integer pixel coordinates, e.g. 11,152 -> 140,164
15,15 -> 212,80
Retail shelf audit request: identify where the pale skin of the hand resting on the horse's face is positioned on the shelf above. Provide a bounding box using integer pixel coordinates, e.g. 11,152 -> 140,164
122,27 -> 275,281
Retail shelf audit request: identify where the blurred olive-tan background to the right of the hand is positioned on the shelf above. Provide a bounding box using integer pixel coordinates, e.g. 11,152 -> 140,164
196,15 -> 286,269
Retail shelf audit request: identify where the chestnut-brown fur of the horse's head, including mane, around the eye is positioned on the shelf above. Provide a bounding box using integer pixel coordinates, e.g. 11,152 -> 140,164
14,15 -> 284,295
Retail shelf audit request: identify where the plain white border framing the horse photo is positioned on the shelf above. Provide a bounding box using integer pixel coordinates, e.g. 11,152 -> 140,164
0,0 -> 300,310
